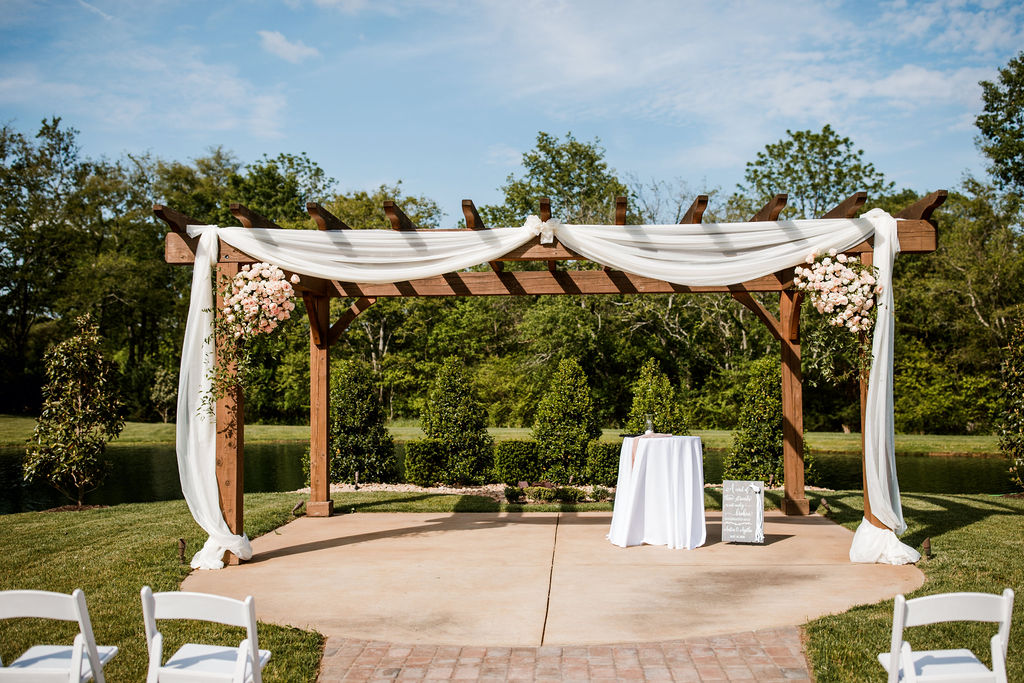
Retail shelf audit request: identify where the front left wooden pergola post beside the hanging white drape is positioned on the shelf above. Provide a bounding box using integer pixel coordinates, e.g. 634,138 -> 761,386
215,263 -> 246,564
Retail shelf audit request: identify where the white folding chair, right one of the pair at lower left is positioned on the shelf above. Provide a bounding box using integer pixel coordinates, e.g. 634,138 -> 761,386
142,586 -> 270,683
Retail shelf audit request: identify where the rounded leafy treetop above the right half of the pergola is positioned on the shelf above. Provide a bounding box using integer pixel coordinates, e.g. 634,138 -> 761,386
736,124 -> 893,220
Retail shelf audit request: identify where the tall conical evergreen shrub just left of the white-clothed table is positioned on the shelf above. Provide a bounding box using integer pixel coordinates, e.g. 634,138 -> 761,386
534,358 -> 601,482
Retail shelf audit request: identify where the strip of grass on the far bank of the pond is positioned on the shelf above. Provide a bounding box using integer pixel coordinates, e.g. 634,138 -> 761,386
0,415 -> 999,456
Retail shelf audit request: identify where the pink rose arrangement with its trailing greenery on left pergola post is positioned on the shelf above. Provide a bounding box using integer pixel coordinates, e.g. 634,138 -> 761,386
203,262 -> 299,411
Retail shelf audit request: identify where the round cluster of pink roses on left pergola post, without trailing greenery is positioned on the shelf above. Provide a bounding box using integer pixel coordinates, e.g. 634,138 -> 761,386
220,263 -> 299,339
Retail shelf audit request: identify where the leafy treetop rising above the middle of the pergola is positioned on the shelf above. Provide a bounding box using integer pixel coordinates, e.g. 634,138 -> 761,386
480,132 -> 629,225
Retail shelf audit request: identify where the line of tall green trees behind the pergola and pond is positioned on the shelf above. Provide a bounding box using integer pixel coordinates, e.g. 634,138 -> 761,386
6,55 -> 1024,433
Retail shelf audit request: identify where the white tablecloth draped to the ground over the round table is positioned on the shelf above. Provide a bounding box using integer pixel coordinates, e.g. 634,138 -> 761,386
608,435 -> 705,550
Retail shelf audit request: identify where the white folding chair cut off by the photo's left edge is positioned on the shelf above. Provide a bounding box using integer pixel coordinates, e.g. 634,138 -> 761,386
0,588 -> 118,683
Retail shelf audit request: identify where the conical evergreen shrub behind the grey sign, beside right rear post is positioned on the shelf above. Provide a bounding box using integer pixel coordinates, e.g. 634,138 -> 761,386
722,356 -> 815,487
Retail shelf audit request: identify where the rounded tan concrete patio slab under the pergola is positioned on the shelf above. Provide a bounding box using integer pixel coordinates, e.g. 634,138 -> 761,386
182,512 -> 924,647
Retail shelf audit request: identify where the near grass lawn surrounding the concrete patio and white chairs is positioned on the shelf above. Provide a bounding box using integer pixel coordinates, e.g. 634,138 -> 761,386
0,489 -> 1024,683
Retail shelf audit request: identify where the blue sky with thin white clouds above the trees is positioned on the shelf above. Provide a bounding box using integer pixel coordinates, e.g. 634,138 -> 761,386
0,0 -> 1024,224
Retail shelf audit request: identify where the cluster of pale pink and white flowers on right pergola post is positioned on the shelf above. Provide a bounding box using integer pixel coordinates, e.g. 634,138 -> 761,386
793,249 -> 882,333
